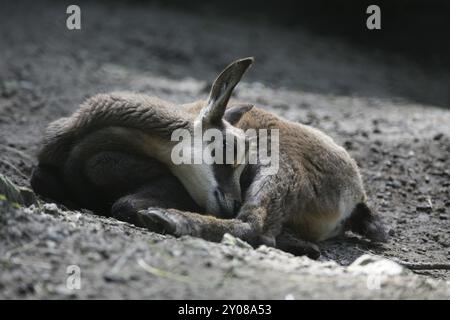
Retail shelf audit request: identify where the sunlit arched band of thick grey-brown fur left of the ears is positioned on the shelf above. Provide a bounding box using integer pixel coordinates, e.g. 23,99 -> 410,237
38,92 -> 189,166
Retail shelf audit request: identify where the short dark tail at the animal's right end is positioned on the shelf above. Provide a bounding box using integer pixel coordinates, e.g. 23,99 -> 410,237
346,202 -> 388,242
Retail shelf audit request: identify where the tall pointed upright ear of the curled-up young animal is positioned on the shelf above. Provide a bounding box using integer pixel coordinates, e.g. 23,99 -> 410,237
200,58 -> 253,124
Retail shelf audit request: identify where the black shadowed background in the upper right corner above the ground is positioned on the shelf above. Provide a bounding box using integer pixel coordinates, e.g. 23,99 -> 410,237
143,0 -> 450,69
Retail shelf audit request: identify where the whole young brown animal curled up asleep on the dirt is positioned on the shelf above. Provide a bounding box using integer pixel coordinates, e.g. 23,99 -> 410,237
32,58 -> 386,253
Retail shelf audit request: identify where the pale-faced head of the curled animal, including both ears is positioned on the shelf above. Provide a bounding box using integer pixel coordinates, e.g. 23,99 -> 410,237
171,58 -> 253,218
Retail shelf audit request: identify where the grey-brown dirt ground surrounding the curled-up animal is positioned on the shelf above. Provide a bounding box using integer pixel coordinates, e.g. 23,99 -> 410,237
0,0 -> 450,299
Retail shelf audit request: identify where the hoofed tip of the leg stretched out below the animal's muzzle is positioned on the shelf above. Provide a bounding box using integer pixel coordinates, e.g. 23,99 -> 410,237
138,208 -> 193,237
